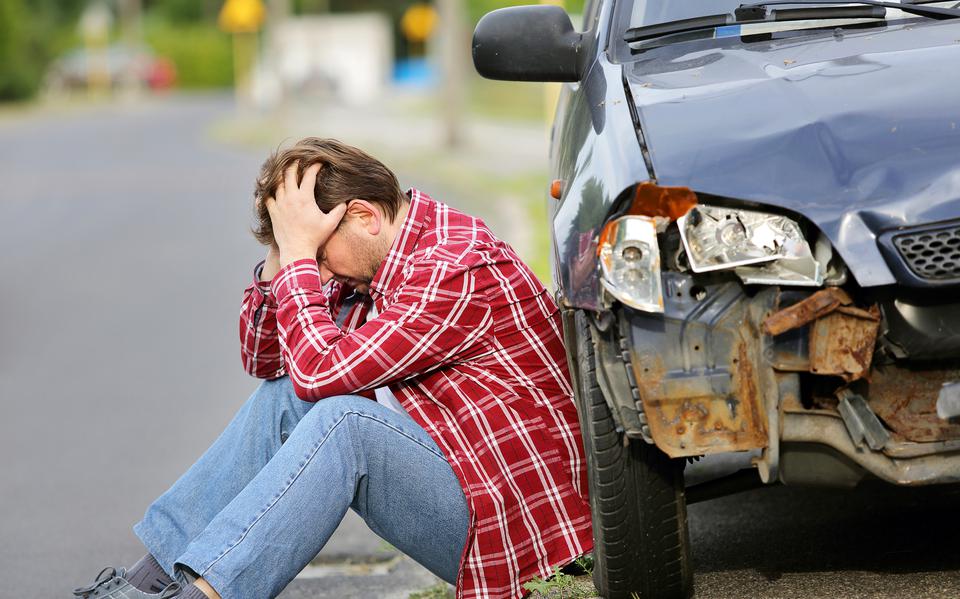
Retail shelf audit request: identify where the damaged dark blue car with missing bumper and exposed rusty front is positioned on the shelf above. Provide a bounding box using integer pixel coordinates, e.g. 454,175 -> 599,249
473,0 -> 960,599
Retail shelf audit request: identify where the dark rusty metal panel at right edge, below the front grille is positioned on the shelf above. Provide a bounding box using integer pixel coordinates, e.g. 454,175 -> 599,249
867,365 -> 960,443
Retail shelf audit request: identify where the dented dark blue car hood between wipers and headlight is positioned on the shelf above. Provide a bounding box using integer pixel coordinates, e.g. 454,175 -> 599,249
624,21 -> 960,286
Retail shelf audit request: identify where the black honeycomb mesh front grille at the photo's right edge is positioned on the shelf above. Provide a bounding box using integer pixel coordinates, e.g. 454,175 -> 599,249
893,221 -> 960,281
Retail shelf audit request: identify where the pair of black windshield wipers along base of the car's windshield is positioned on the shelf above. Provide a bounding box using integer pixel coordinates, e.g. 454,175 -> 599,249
623,0 -> 960,43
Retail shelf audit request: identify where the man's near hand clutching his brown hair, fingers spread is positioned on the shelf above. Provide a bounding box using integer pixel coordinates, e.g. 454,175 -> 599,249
266,163 -> 347,267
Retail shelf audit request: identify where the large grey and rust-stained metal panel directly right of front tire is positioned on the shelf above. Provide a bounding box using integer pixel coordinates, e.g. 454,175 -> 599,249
625,282 -> 778,457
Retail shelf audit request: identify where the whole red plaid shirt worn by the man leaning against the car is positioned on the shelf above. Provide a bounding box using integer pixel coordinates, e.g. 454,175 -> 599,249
240,190 -> 592,598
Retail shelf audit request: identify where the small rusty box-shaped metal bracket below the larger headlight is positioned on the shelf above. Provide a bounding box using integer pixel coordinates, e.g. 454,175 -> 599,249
810,306 -> 880,382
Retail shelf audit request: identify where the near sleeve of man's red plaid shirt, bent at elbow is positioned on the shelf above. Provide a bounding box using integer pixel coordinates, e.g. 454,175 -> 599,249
272,260 -> 493,401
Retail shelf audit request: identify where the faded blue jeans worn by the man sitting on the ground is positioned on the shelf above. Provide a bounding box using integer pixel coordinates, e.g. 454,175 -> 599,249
134,377 -> 470,599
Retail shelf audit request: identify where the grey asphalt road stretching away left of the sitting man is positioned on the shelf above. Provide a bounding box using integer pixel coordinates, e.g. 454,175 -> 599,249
0,98 -> 274,597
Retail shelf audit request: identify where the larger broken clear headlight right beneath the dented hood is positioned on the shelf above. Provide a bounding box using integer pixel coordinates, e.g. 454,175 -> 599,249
677,204 -> 823,286
